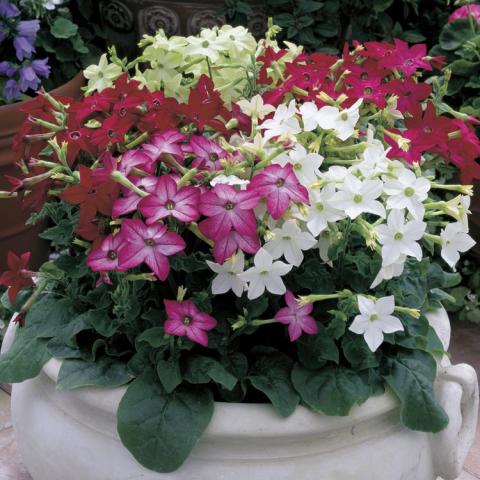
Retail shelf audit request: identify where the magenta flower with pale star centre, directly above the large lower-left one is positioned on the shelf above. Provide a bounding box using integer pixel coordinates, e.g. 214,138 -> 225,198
138,175 -> 200,225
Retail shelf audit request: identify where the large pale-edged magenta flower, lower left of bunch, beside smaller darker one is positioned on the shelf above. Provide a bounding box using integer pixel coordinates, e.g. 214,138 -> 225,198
118,218 -> 186,281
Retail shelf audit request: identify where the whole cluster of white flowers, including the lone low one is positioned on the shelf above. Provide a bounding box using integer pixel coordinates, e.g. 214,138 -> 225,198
204,97 -> 474,350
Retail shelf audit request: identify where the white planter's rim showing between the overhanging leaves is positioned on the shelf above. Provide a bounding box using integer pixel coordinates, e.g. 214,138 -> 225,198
43,358 -> 400,439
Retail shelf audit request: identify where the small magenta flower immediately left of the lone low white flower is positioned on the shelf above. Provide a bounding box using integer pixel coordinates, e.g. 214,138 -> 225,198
274,290 -> 318,342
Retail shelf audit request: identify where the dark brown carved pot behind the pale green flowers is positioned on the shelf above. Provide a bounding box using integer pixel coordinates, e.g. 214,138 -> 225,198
99,0 -> 267,56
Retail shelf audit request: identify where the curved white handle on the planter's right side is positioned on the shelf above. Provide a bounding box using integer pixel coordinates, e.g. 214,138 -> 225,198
431,363 -> 479,480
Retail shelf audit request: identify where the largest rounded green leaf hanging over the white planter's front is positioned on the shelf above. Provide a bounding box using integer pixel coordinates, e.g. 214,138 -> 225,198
117,372 -> 214,473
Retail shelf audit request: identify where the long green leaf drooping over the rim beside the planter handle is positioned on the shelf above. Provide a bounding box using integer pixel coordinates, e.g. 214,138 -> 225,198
383,350 -> 448,433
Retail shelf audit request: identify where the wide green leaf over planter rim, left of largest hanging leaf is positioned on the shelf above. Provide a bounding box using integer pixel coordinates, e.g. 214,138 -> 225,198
57,356 -> 131,390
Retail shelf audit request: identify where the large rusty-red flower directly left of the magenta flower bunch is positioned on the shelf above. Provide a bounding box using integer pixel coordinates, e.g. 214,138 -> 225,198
60,165 -> 119,217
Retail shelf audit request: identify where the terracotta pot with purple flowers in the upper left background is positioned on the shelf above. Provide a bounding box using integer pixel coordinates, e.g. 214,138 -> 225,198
0,0 -> 103,270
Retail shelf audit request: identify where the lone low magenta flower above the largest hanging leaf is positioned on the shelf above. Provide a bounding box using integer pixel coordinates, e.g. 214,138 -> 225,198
163,300 -> 217,347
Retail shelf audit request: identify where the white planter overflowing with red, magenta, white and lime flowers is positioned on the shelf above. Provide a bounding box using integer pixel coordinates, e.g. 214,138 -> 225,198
0,25 -> 480,480
